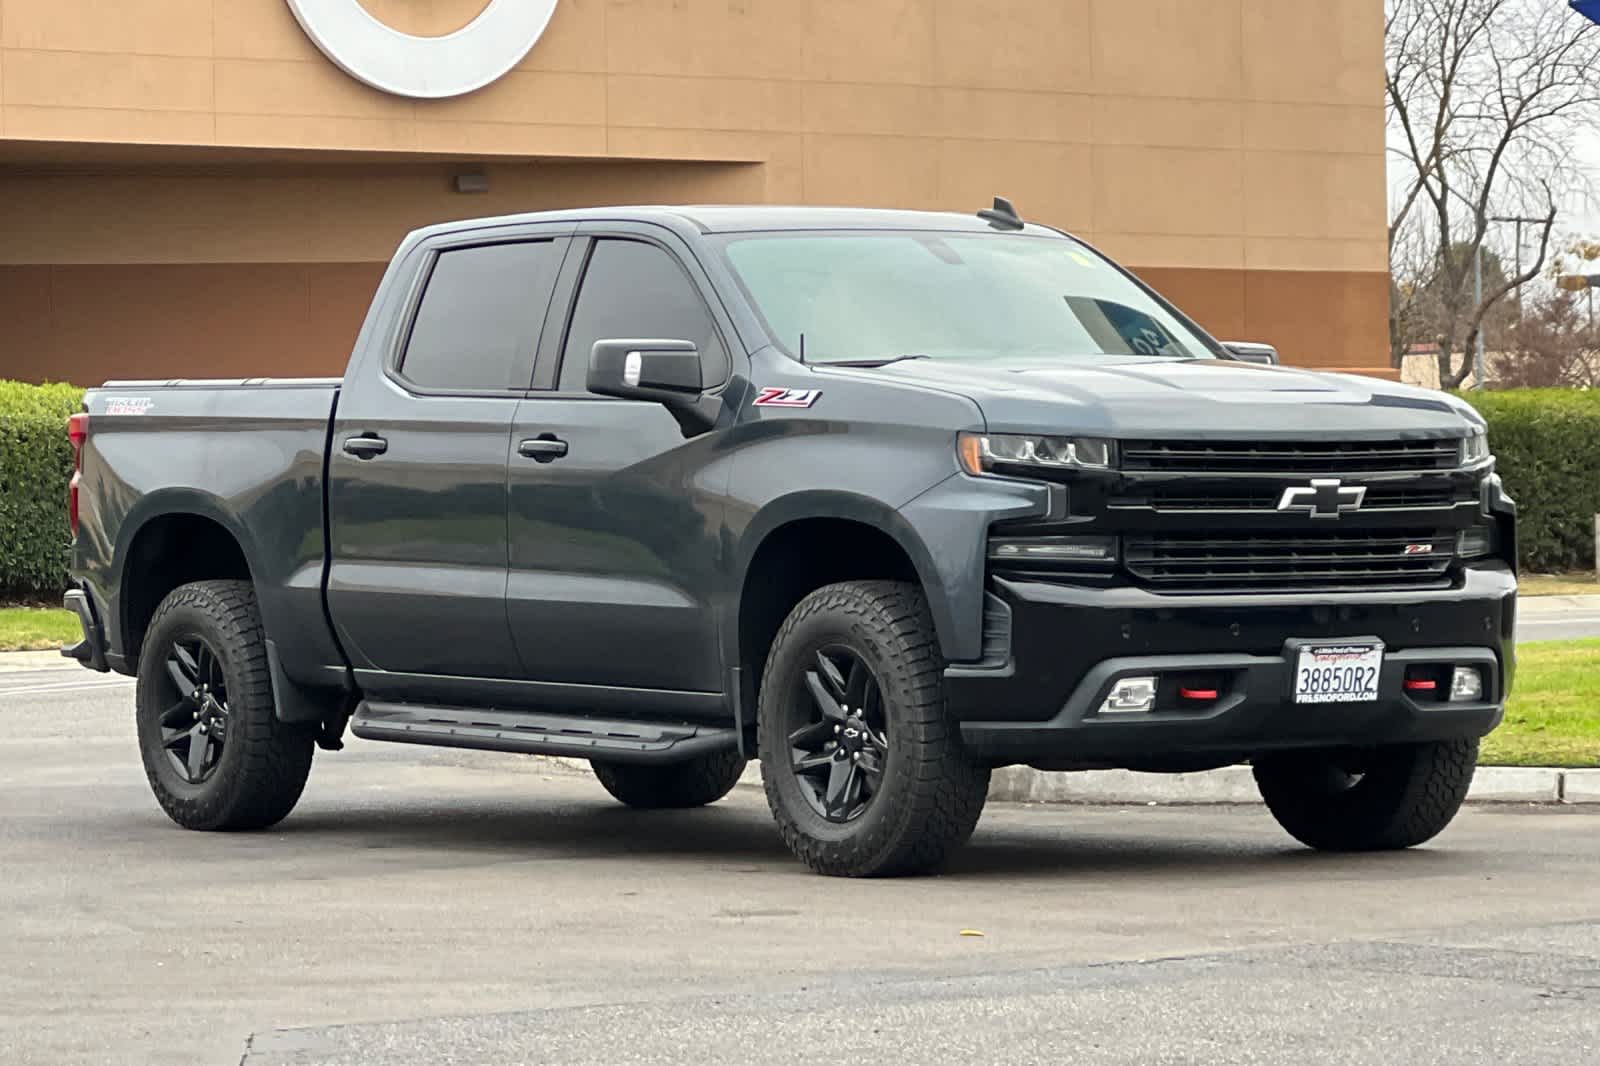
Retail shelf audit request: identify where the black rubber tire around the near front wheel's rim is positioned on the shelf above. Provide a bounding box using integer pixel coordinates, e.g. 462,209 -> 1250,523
757,581 -> 989,877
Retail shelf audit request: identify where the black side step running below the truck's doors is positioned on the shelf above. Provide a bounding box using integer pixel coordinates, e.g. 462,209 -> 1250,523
350,701 -> 739,763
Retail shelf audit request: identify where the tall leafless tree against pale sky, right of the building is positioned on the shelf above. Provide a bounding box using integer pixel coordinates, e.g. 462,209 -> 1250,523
1386,0 -> 1600,387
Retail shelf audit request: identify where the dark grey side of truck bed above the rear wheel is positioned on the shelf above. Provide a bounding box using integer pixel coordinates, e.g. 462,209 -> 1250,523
74,378 -> 342,682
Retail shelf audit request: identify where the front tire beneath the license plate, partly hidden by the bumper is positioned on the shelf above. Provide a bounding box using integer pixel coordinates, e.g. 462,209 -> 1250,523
1254,739 -> 1478,852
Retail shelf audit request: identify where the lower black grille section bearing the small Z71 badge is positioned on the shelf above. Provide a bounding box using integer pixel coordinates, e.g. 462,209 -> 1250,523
1123,530 -> 1456,592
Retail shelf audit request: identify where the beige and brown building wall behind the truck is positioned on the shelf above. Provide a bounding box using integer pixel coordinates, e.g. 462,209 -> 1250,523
0,0 -> 1389,381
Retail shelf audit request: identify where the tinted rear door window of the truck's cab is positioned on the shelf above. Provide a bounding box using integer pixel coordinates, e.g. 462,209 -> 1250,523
400,240 -> 562,389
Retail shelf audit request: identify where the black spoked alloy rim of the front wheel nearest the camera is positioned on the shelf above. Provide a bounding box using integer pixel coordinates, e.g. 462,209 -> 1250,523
789,645 -> 890,824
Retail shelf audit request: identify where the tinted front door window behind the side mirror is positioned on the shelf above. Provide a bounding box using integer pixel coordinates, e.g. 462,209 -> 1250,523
560,240 -> 728,392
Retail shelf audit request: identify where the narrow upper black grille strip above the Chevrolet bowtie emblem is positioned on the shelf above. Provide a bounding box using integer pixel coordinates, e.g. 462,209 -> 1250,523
1122,440 -> 1461,477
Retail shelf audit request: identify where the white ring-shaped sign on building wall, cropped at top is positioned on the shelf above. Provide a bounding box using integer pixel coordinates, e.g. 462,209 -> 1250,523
288,0 -> 557,99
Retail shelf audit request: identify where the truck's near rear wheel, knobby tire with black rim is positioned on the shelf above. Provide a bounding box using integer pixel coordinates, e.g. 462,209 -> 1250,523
134,581 -> 315,829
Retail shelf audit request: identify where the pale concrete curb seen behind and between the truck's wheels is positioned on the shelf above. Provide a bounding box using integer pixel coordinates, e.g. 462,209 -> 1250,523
546,757 -> 1600,807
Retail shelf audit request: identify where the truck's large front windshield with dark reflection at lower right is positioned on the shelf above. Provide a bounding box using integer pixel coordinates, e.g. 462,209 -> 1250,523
723,230 -> 1213,363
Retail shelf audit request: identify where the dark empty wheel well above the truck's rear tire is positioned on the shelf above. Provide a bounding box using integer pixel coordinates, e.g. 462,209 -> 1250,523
122,514 -> 250,664
